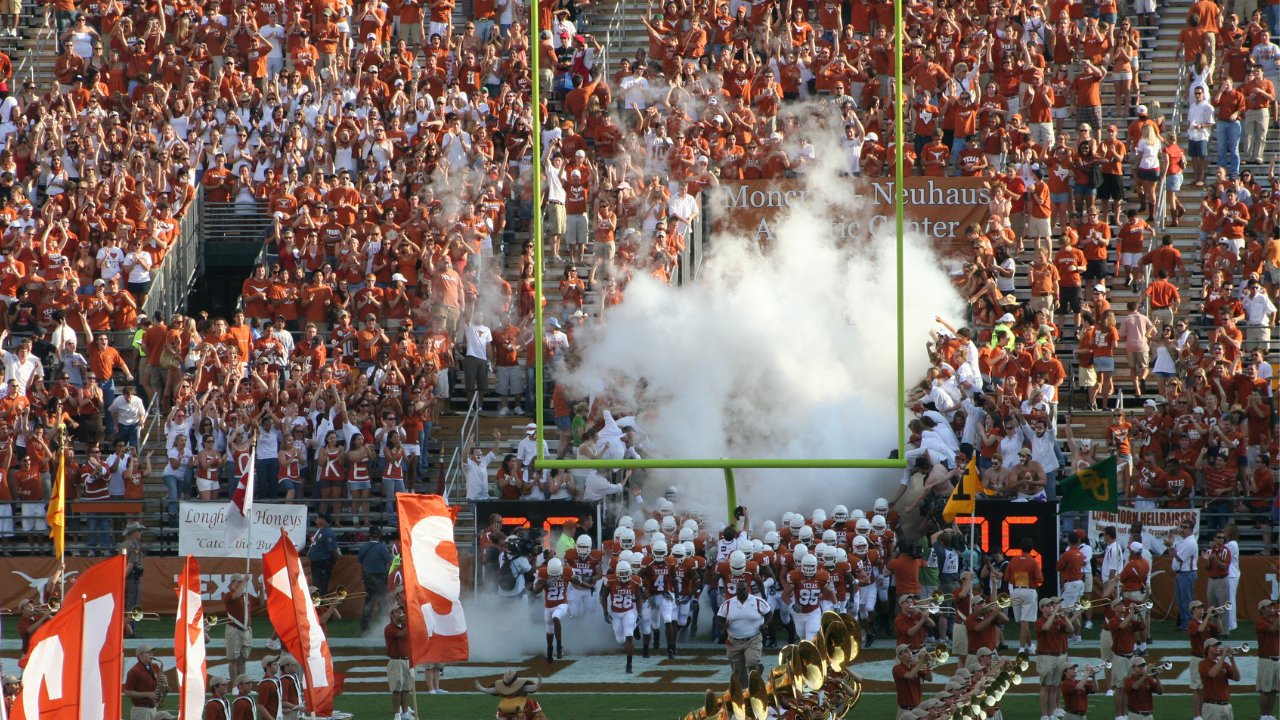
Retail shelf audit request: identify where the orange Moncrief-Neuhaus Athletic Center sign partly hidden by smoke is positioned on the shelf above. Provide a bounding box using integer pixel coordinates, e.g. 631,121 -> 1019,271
709,177 -> 991,258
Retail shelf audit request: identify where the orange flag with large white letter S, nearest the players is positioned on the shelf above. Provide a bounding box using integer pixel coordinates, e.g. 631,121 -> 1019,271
396,492 -> 471,665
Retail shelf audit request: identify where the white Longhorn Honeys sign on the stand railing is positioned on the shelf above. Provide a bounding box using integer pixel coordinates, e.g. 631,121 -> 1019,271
178,502 -> 307,560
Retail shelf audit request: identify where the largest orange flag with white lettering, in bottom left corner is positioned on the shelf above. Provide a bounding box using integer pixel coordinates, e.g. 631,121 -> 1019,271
13,555 -> 125,720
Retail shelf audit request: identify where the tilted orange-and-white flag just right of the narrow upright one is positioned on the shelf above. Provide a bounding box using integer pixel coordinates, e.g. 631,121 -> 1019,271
262,528 -> 337,716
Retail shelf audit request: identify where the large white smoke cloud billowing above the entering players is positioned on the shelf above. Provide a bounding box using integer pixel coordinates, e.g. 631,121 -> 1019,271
555,110 -> 964,521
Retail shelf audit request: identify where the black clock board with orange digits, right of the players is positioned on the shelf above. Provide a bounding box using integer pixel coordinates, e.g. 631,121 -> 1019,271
956,500 -> 1061,597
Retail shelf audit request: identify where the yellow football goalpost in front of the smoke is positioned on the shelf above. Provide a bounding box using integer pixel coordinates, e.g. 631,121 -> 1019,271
529,0 -> 906,521
